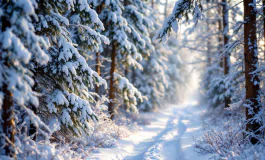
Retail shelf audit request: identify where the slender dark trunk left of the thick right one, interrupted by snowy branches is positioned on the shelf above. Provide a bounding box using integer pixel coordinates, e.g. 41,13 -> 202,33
222,0 -> 231,108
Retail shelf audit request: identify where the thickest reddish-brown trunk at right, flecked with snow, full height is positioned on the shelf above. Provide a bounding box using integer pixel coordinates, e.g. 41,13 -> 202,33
244,0 -> 261,144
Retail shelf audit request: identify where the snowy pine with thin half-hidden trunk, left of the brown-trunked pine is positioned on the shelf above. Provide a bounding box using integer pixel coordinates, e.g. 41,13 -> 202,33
67,0 -> 109,106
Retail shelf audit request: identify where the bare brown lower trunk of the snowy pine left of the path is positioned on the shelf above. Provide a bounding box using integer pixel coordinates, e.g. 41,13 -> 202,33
108,42 -> 116,119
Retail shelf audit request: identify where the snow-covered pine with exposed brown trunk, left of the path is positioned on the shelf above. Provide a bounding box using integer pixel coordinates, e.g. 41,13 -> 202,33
90,0 -> 145,118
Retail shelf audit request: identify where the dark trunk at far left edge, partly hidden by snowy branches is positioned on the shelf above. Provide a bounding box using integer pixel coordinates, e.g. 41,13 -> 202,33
1,1 -> 16,158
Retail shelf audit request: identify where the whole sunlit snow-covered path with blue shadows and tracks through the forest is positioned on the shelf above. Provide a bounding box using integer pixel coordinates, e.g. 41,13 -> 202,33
90,104 -> 208,160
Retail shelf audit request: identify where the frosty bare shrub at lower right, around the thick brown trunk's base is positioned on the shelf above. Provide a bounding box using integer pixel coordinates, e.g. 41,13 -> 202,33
194,101 -> 265,160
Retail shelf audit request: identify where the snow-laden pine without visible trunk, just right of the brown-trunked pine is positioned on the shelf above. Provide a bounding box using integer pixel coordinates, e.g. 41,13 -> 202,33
123,0 -> 167,111
